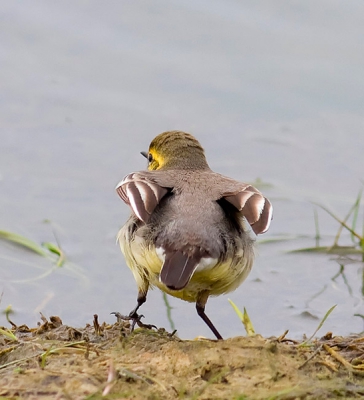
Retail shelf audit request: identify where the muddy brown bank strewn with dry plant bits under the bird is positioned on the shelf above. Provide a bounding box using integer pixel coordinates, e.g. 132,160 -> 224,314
0,316 -> 364,400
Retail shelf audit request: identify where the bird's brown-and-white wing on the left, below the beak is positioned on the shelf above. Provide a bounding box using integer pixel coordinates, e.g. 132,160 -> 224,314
116,172 -> 169,223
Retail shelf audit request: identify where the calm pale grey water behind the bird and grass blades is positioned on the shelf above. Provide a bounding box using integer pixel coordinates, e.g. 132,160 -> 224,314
0,0 -> 364,338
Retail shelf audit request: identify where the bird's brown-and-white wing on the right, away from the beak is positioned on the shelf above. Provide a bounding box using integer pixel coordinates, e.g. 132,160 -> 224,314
222,185 -> 273,234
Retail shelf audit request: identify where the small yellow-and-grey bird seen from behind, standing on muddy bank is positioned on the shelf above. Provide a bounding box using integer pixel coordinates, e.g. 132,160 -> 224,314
116,131 -> 272,339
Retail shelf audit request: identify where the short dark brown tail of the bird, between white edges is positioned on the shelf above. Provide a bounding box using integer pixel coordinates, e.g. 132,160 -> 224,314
159,251 -> 199,290
